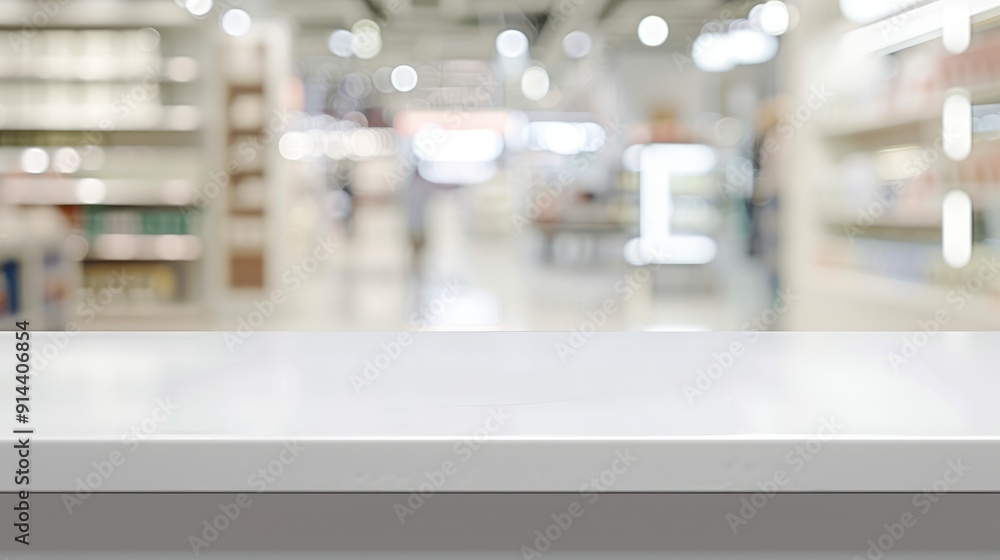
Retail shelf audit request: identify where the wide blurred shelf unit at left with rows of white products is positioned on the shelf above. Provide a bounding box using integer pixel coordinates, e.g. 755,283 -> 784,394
0,21 -> 209,322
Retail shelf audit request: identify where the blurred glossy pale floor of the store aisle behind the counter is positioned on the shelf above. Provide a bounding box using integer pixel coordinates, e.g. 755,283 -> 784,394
90,193 -> 767,331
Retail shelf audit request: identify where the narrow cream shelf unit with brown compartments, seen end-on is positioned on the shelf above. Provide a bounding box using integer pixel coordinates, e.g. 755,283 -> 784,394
215,20 -> 292,300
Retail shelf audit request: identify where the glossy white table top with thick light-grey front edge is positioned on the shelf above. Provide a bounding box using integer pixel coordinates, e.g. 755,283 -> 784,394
0,332 -> 1000,492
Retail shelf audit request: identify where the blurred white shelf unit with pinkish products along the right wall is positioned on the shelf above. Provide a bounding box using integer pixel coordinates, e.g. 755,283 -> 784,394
786,6 -> 1000,330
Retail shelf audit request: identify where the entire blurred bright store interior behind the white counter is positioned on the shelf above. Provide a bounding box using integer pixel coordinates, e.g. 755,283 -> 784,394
0,0 -> 1000,334
